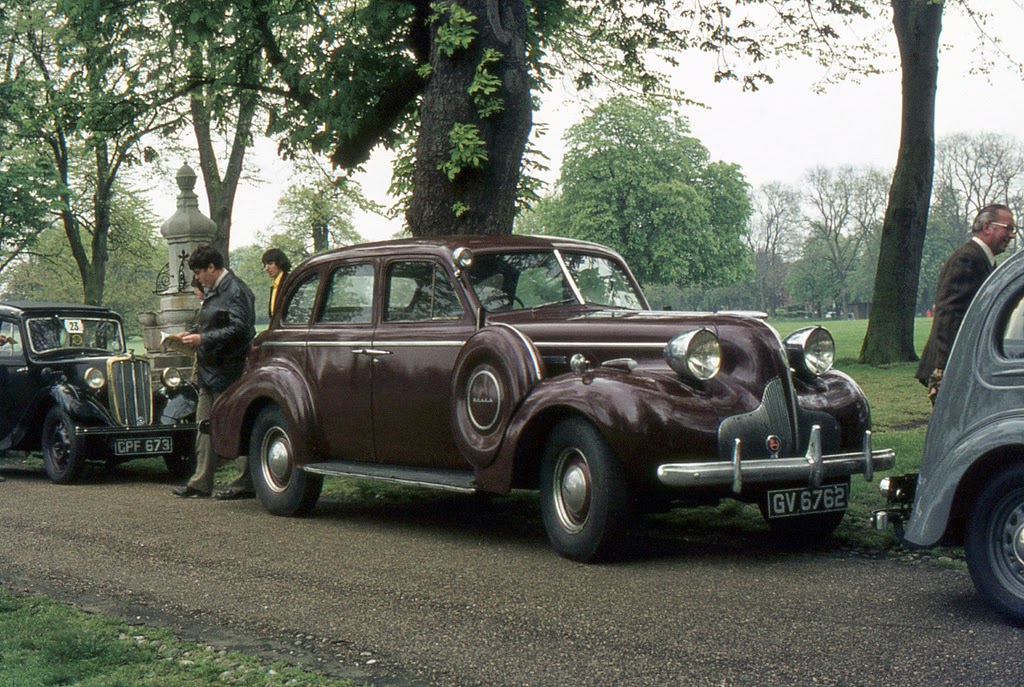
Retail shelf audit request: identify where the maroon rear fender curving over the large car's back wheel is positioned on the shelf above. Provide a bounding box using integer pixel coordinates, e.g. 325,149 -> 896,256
210,360 -> 317,463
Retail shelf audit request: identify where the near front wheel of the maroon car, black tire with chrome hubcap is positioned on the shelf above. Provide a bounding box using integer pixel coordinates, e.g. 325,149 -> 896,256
541,418 -> 633,563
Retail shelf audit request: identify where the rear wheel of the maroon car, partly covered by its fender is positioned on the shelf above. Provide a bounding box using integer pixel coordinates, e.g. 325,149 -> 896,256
249,405 -> 324,515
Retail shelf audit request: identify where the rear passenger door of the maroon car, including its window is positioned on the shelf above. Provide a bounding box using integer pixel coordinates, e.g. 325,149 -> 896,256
306,260 -> 376,461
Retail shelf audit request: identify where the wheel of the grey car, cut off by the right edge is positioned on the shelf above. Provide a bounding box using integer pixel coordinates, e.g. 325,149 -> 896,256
964,465 -> 1024,625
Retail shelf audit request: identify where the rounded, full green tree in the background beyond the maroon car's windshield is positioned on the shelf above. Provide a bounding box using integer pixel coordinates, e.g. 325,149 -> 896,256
540,98 -> 751,286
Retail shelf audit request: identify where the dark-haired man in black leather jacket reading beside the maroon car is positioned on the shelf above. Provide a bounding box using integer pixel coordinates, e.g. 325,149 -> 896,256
173,246 -> 256,499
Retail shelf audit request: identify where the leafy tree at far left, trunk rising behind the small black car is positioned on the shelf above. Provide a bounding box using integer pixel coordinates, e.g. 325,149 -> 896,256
0,0 -> 182,304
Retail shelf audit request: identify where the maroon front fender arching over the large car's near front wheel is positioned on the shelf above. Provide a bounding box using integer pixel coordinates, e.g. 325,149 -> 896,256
477,369 -> 720,491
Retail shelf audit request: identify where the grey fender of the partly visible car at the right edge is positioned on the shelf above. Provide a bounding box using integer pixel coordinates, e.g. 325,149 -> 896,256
904,413 -> 1024,546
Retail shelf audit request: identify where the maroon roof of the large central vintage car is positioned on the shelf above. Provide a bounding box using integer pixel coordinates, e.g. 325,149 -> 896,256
292,234 -> 622,272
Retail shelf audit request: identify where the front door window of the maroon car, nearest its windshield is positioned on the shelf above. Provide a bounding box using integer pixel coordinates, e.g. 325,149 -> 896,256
384,261 -> 463,323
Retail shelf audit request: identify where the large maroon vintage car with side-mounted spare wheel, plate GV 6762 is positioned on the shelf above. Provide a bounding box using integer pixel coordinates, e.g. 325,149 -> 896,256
205,237 -> 894,561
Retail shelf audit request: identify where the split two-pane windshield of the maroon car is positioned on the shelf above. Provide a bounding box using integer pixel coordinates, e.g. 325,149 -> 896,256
469,251 -> 643,312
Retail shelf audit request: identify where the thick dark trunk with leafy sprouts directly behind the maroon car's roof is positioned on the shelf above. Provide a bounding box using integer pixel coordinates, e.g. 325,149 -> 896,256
407,0 -> 532,237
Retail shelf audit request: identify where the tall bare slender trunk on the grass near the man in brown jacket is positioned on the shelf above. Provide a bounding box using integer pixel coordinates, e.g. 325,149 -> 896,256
860,0 -> 943,364
